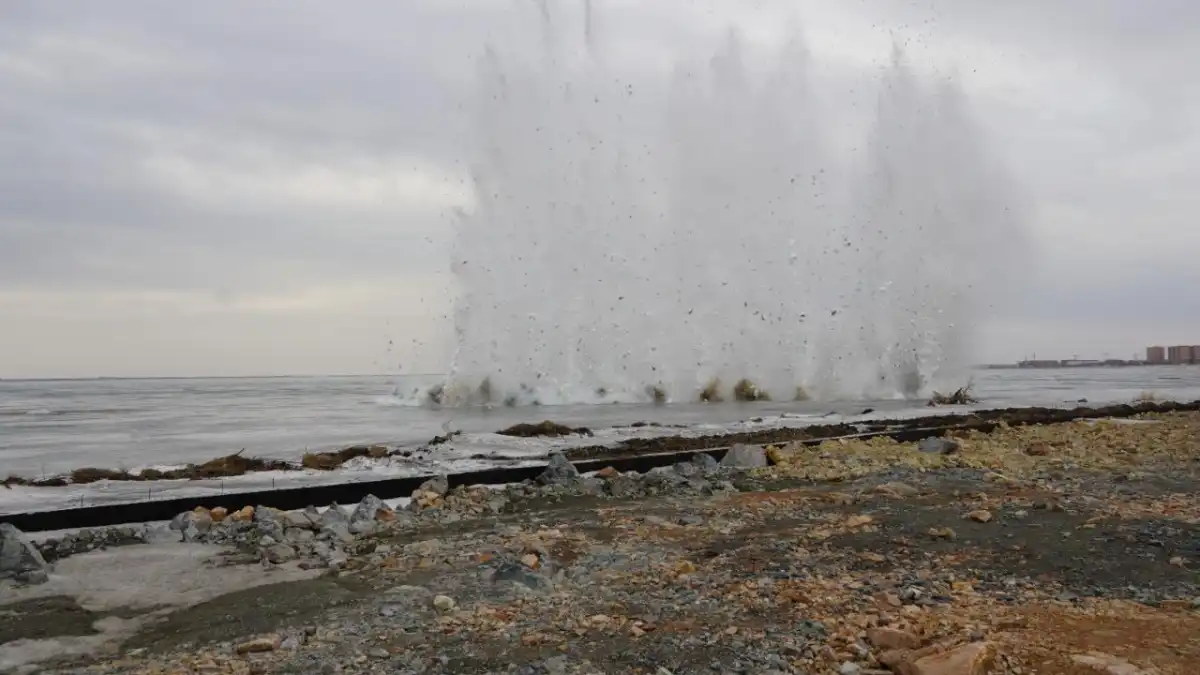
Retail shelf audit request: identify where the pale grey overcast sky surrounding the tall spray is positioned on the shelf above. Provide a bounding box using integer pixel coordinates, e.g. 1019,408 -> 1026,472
0,0 -> 1200,377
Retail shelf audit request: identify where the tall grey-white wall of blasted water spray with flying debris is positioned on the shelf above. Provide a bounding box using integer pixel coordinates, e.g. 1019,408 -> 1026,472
439,4 -> 1020,405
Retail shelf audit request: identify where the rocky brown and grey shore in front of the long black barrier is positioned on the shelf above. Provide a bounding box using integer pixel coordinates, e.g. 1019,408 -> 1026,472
0,412 -> 1200,675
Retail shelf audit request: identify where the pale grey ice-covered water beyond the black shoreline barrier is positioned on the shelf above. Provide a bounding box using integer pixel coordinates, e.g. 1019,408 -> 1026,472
0,366 -> 1200,513
